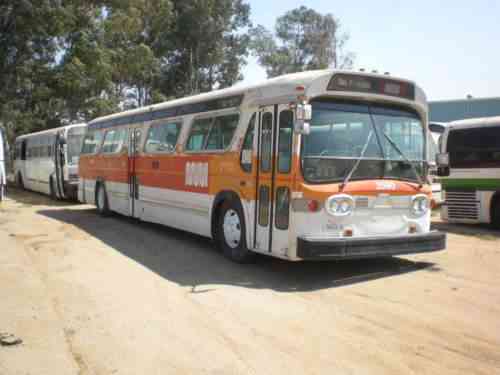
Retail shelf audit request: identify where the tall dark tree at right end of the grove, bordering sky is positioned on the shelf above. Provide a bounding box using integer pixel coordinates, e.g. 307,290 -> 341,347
158,0 -> 250,97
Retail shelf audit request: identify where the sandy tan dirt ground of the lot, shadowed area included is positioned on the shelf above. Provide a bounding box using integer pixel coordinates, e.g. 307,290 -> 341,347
0,190 -> 500,375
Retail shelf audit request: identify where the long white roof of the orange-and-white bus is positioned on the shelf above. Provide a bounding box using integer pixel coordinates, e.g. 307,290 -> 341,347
89,69 -> 423,128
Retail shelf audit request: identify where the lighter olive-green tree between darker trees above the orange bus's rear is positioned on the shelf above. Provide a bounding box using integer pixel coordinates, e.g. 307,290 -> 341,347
104,0 -> 173,108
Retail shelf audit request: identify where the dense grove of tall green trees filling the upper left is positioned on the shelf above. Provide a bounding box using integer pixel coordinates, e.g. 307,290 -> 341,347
0,0 -> 250,145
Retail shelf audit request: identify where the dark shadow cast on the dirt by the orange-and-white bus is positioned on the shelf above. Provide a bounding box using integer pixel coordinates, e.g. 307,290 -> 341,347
38,209 -> 440,293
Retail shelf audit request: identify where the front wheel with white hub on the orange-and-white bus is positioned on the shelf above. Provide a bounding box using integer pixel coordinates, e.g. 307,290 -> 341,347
217,200 -> 255,263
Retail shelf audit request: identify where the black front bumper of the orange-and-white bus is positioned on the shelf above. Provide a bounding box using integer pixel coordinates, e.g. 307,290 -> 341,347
297,231 -> 446,260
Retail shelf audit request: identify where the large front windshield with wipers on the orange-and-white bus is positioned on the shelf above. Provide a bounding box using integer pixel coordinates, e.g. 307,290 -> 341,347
302,101 -> 426,183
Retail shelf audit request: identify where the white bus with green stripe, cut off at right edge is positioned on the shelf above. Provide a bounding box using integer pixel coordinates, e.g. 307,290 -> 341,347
437,117 -> 500,229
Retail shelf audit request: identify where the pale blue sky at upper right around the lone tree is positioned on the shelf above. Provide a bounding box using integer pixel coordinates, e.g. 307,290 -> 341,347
243,0 -> 500,100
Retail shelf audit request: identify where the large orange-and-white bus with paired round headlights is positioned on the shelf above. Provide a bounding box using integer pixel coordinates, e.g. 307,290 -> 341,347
78,70 -> 446,263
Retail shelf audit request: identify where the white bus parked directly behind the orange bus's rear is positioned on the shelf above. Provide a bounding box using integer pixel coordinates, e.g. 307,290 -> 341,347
14,124 -> 87,200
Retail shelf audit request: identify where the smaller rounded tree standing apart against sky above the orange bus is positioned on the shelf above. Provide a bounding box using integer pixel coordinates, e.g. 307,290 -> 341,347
250,6 -> 354,77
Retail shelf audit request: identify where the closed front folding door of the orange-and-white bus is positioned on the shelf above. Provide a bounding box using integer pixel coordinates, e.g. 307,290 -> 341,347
254,105 -> 293,257
